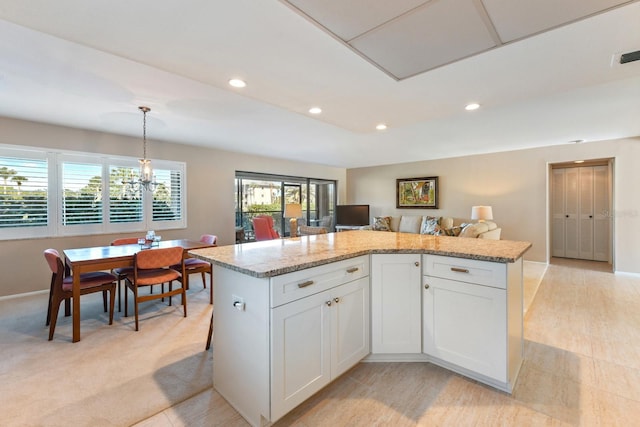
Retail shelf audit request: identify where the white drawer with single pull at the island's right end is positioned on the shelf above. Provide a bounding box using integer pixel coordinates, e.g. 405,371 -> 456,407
423,255 -> 507,289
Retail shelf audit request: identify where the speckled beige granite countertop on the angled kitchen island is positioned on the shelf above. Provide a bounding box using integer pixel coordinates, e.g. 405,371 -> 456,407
189,230 -> 531,277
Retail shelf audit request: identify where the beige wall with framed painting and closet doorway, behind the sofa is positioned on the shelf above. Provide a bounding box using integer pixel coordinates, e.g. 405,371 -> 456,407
347,138 -> 640,273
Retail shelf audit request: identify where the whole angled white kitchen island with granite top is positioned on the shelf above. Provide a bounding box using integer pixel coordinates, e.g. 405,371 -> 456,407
190,230 -> 531,425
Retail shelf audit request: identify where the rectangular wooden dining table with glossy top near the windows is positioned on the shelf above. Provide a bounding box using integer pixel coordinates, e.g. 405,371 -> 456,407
62,239 -> 213,342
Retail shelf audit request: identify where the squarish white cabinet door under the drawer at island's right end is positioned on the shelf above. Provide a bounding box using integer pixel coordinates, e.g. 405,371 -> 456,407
423,276 -> 507,382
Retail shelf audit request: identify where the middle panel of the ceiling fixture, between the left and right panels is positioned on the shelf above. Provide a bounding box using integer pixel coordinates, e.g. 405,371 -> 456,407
350,0 -> 496,79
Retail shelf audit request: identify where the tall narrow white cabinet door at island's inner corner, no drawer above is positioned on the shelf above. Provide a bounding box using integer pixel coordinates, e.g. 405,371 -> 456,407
371,254 -> 422,354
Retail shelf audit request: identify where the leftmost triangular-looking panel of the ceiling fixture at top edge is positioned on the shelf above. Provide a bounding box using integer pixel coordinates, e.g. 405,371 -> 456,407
287,0 -> 429,41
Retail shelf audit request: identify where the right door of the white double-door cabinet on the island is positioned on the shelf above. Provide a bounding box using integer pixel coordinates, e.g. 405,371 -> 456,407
331,277 -> 370,379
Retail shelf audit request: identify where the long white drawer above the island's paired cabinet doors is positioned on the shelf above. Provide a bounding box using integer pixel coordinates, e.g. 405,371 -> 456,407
271,255 -> 369,308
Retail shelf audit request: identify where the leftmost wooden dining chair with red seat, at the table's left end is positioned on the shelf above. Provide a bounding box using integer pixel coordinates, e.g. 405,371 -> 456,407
44,249 -> 117,341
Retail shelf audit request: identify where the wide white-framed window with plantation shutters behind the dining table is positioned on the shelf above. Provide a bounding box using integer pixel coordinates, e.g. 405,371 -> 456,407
0,145 -> 186,240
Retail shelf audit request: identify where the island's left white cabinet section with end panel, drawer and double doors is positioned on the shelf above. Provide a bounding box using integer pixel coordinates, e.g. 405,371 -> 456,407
213,255 -> 370,425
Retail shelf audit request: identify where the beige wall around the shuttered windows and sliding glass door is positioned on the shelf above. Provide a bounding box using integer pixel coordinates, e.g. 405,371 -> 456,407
0,118 -> 346,297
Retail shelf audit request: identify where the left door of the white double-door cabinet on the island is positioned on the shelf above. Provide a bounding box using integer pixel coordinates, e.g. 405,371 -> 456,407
270,291 -> 332,420
